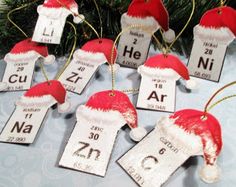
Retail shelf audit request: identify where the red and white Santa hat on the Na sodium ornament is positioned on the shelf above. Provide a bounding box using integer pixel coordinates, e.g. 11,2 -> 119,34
16,80 -> 70,113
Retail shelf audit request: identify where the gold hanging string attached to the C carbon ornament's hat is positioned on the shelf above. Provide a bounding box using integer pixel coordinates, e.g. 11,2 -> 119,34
203,81 -> 236,118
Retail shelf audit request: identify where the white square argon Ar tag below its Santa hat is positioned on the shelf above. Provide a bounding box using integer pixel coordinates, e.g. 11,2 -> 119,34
137,76 -> 176,112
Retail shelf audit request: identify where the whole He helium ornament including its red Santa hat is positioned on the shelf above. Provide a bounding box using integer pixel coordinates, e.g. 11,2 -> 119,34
117,0 -> 175,68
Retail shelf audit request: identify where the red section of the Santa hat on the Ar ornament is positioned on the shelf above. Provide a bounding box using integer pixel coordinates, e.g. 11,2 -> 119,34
144,54 -> 190,80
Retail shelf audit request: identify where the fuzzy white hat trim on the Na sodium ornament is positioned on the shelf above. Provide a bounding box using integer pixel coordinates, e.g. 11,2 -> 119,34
16,95 -> 57,106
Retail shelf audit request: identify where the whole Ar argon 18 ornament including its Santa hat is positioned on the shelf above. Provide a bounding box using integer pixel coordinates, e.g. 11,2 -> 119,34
137,54 -> 196,112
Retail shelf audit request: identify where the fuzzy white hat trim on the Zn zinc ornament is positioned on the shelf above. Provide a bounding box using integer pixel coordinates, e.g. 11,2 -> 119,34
76,105 -> 127,125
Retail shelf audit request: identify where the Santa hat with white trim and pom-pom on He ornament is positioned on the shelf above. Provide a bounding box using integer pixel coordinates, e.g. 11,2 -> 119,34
122,0 -> 175,43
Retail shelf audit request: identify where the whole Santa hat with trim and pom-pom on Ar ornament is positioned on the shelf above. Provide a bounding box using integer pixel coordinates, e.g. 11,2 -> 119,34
138,54 -> 196,89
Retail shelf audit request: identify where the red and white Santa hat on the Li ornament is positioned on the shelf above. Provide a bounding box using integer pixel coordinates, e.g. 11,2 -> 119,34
37,0 -> 84,23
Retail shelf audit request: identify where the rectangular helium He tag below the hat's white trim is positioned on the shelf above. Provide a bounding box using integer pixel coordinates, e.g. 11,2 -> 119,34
117,29 -> 151,68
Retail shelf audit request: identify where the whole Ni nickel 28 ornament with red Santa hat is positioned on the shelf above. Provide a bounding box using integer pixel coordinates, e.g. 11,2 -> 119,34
188,6 -> 236,82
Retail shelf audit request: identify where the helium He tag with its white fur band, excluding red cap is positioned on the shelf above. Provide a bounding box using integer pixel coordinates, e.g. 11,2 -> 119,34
117,13 -> 159,68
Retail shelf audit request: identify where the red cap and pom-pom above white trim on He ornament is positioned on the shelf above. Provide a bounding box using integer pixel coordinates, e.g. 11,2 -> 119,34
127,0 -> 175,43
